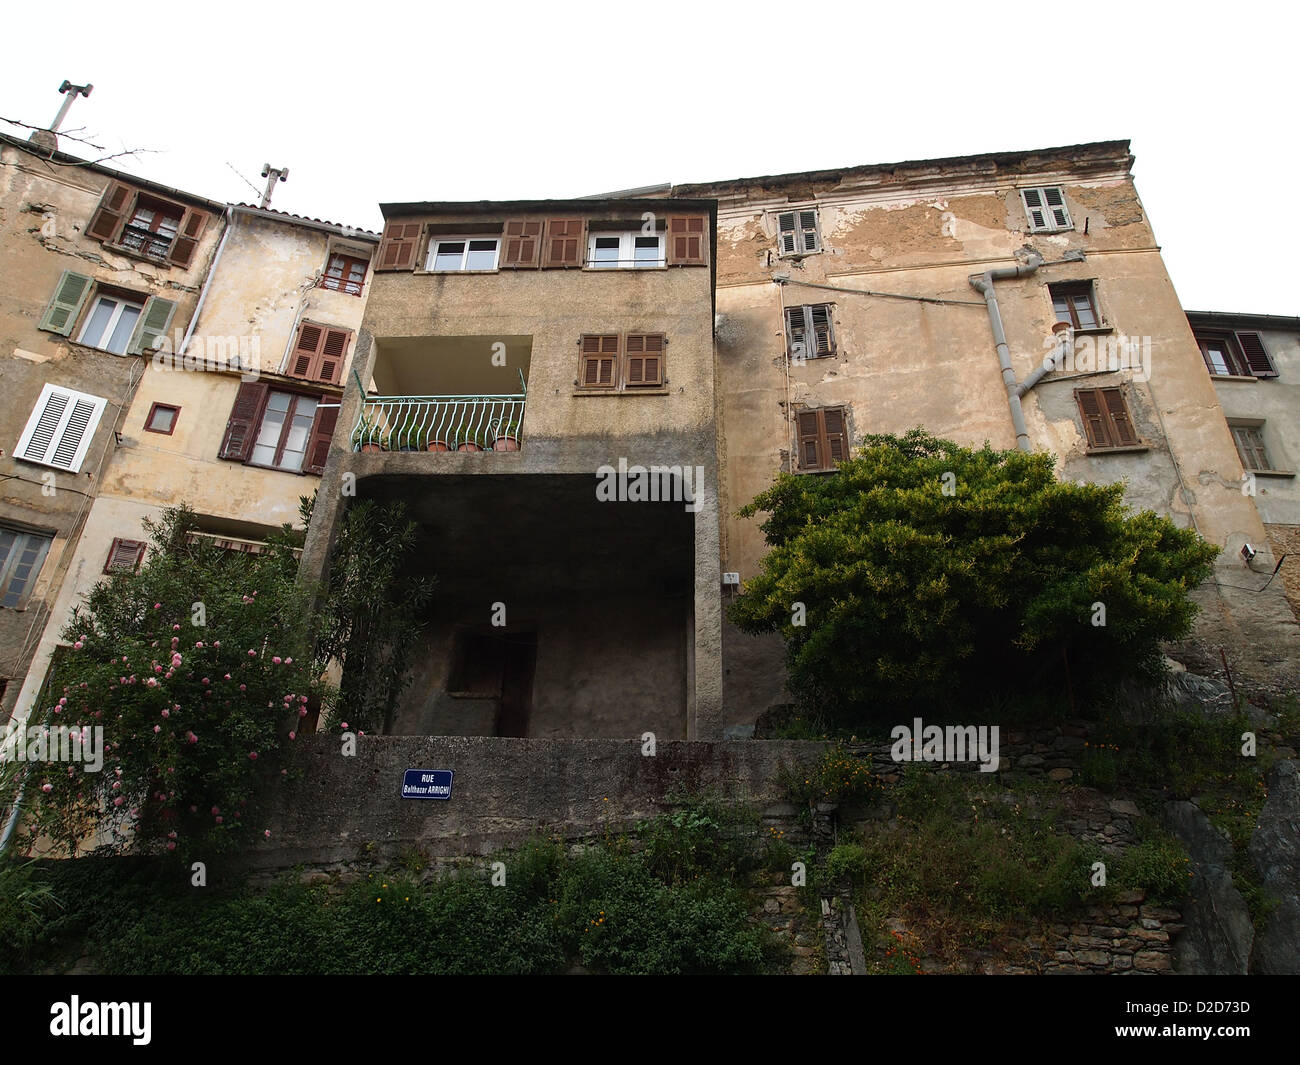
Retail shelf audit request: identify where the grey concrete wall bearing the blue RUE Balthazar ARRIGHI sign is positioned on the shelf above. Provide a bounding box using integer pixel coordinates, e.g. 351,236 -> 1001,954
239,736 -> 826,870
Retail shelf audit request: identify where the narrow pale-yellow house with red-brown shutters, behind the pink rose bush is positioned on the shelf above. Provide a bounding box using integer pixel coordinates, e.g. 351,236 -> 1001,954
7,204 -> 378,728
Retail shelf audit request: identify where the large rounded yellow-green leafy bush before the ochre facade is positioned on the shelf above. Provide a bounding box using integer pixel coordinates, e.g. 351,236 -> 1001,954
731,429 -> 1218,722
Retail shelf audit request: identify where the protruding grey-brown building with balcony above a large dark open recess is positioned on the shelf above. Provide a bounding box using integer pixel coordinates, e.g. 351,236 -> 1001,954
303,199 -> 722,740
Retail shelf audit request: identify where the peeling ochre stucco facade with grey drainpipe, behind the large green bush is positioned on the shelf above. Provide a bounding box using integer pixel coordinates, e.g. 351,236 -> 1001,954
672,142 -> 1300,707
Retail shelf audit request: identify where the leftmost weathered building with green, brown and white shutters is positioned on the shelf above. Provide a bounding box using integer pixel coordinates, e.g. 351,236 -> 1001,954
0,134 -> 221,718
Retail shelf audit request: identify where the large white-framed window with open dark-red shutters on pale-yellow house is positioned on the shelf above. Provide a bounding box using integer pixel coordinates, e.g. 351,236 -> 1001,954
217,381 -> 339,473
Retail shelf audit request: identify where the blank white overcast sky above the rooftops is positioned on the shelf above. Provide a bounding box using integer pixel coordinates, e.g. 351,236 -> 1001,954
0,0 -> 1300,315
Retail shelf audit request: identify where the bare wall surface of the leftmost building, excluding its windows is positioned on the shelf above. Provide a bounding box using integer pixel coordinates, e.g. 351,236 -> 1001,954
0,139 -> 222,718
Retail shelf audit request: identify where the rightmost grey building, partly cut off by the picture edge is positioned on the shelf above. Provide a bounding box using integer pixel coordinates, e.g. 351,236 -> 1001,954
1187,311 -> 1300,618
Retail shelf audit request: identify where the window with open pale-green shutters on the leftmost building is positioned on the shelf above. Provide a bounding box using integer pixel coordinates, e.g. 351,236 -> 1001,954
36,270 -> 176,355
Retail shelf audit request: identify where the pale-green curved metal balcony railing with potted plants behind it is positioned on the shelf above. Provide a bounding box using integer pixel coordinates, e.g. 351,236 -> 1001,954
351,393 -> 527,451
